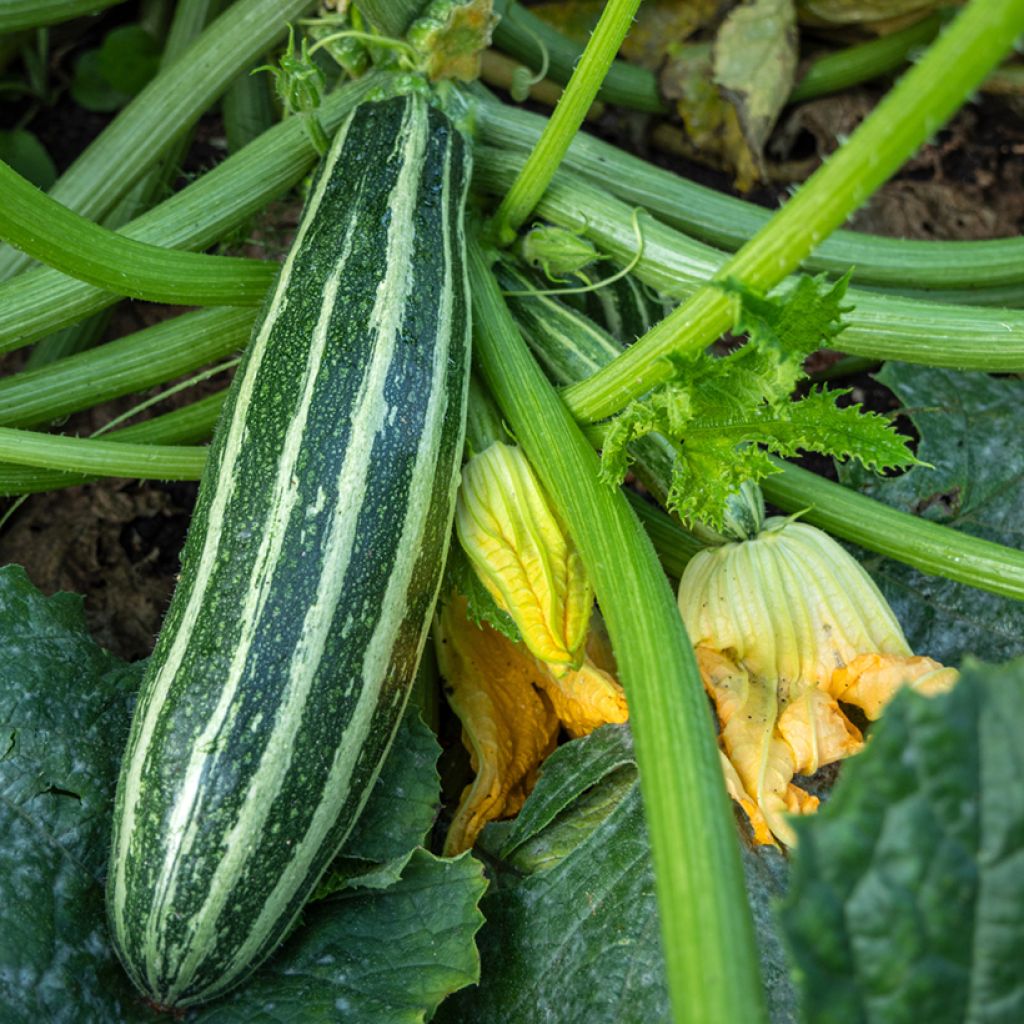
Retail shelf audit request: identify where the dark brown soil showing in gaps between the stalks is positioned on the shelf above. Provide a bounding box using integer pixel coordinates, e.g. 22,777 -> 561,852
0,16 -> 1024,659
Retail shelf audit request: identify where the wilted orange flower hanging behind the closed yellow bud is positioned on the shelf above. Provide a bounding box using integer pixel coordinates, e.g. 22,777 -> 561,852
434,595 -> 629,856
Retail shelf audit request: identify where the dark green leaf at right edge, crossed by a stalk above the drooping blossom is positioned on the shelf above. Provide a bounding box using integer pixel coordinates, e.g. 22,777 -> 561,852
840,362 -> 1024,665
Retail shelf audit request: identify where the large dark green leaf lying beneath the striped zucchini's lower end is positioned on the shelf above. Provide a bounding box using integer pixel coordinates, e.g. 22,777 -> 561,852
0,566 -> 485,1024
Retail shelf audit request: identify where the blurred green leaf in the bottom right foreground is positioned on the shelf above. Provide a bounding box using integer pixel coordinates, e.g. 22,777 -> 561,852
782,659 -> 1024,1024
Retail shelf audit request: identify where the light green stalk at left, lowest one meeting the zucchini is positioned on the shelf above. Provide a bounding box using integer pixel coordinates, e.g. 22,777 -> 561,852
0,427 -> 206,480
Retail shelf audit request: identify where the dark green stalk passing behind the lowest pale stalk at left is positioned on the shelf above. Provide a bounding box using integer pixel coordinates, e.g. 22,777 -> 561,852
0,390 -> 227,498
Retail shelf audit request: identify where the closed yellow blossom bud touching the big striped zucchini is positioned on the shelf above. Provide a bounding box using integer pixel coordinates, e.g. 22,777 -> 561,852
455,441 -> 594,674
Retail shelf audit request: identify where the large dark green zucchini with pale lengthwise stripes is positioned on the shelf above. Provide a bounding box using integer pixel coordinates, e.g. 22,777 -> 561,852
108,95 -> 469,1007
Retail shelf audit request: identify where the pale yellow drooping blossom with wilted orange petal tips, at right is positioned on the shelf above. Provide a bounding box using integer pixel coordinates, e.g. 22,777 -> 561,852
679,517 -> 957,845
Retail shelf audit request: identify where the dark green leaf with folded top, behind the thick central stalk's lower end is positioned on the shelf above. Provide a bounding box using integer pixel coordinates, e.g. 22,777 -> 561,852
436,726 -> 796,1024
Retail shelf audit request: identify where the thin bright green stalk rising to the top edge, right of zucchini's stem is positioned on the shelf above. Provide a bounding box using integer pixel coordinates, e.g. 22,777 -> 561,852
494,0 -> 640,246
